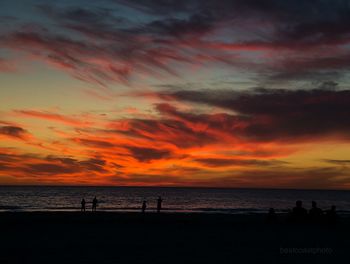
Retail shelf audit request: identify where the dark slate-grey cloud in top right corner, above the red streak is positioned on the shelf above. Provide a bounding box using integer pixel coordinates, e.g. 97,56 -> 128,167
120,0 -> 350,45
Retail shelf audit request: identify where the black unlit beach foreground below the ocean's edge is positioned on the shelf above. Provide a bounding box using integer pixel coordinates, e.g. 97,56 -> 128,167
0,212 -> 350,264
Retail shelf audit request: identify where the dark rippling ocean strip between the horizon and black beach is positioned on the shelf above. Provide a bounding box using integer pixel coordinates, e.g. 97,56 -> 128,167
0,186 -> 350,214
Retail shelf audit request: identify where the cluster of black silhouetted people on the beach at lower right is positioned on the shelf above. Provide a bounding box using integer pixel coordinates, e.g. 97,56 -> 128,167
267,200 -> 337,224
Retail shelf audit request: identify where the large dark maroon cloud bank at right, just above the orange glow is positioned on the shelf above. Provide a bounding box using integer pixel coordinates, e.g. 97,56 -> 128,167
158,89 -> 350,141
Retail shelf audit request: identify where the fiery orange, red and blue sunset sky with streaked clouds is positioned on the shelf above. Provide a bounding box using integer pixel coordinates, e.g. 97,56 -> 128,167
0,0 -> 350,189
